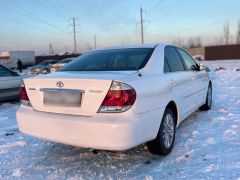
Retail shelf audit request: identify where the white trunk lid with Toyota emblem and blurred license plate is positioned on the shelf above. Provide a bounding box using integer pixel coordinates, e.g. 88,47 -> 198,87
24,71 -> 136,116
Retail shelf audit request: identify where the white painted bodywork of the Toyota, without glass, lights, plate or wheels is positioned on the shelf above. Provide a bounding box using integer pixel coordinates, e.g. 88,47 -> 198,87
17,44 -> 210,150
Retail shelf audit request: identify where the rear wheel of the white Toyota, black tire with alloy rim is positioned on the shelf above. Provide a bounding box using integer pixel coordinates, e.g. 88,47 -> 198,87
147,108 -> 176,156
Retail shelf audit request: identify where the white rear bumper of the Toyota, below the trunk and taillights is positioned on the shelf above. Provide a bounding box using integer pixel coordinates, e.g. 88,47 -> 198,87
17,105 -> 162,150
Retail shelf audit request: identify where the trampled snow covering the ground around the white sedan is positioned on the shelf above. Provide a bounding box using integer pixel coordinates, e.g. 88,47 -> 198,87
0,61 -> 240,179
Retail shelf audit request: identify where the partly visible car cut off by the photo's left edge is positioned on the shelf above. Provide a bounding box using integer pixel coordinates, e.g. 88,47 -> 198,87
0,65 -> 22,101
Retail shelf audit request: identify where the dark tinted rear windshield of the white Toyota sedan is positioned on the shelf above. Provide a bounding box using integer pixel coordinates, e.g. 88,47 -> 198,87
60,48 -> 154,71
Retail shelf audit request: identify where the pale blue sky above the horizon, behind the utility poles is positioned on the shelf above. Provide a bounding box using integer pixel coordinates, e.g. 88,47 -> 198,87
0,0 -> 240,54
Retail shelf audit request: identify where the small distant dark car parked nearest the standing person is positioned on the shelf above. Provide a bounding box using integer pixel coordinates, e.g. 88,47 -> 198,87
31,60 -> 58,74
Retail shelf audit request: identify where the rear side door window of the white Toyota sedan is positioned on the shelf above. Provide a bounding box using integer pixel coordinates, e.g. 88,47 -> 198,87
164,47 -> 185,72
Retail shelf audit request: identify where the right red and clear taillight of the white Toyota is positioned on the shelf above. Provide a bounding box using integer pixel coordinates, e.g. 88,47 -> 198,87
98,81 -> 136,113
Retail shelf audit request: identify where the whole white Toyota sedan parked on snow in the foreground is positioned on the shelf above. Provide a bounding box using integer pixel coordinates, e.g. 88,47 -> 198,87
17,44 -> 212,155
